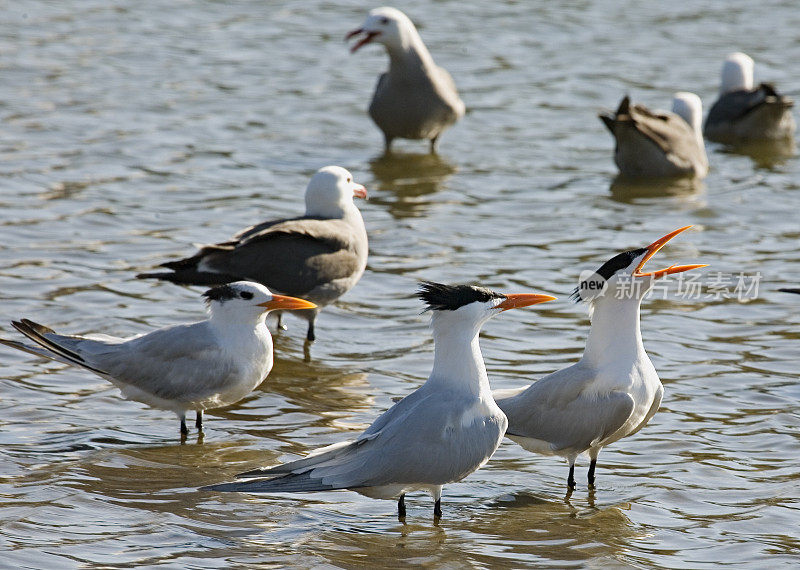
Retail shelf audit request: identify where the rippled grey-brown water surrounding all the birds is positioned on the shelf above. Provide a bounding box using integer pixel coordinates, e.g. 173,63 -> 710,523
0,0 -> 800,568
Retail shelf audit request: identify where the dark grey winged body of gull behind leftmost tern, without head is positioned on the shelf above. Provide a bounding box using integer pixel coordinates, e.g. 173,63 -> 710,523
150,218 -> 367,296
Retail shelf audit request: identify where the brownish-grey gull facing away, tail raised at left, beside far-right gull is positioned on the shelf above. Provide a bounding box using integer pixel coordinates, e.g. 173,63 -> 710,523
600,91 -> 708,178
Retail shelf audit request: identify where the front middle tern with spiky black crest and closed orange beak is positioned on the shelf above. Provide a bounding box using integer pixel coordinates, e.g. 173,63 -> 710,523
203,282 -> 555,519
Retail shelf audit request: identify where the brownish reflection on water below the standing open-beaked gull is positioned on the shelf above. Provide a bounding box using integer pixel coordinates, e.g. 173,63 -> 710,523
369,152 -> 458,219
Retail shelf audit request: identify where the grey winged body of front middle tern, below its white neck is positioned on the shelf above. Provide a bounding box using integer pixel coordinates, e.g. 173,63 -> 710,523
211,387 -> 505,492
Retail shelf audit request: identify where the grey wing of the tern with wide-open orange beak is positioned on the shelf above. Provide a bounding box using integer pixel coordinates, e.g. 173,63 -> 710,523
495,362 -> 634,451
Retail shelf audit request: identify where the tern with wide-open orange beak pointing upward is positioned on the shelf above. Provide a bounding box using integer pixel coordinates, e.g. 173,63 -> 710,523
494,226 -> 705,491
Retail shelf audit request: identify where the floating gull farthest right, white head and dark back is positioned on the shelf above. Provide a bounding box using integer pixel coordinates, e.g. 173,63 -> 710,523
705,52 -> 795,144
